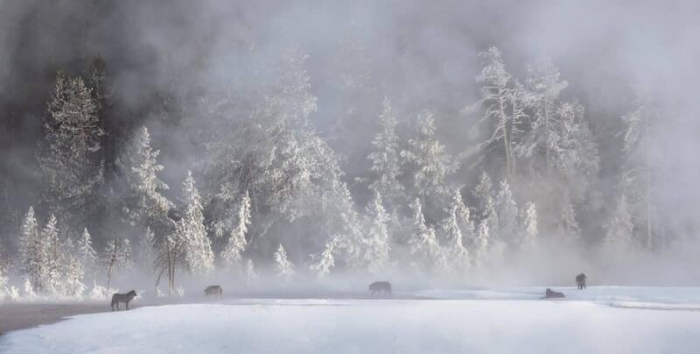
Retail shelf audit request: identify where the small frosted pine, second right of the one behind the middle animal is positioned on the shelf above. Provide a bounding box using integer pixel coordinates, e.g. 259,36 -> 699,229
441,190 -> 474,274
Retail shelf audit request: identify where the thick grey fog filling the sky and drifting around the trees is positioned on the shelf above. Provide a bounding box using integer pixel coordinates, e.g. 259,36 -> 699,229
0,0 -> 700,296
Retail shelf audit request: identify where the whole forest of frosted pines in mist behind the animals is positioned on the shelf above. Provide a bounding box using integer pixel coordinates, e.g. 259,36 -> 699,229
0,0 -> 688,296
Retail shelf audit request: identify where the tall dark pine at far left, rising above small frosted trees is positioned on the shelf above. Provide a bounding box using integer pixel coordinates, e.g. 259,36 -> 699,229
39,72 -> 104,226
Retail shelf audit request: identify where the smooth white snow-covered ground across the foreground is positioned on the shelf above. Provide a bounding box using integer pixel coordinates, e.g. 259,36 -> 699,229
0,287 -> 700,354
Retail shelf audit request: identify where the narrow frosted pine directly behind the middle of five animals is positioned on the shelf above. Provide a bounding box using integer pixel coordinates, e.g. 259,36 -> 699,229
365,192 -> 391,274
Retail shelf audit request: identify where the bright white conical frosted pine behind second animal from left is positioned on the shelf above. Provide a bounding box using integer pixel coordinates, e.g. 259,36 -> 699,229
177,171 -> 214,274
